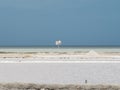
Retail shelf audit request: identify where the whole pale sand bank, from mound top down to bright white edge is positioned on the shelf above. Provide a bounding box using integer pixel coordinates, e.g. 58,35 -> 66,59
0,51 -> 120,63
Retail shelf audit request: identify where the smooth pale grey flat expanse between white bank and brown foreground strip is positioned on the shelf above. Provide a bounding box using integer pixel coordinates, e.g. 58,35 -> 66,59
0,63 -> 120,84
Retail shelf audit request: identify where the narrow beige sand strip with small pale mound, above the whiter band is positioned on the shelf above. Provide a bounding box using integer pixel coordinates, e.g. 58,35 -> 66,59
0,50 -> 120,59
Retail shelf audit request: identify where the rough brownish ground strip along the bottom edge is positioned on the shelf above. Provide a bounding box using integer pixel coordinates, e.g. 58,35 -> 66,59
0,83 -> 120,90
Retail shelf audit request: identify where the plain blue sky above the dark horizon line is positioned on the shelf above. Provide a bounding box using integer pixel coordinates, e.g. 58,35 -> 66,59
0,0 -> 120,46
